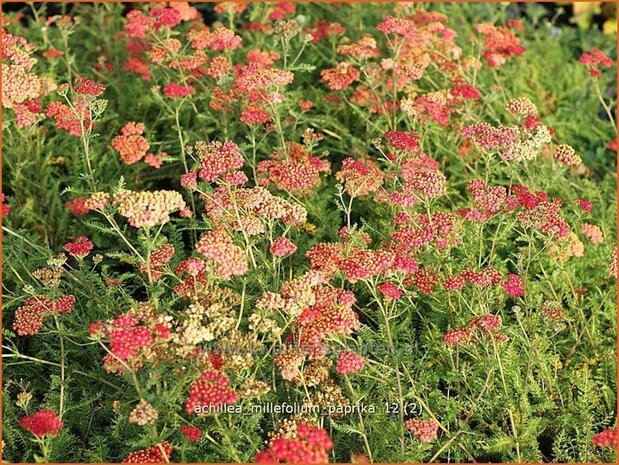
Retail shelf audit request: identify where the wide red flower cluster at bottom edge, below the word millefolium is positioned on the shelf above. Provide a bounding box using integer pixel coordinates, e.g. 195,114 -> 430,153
255,423 -> 333,463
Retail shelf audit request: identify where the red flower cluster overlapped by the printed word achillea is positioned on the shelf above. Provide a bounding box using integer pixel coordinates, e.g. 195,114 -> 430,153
185,370 -> 236,415
